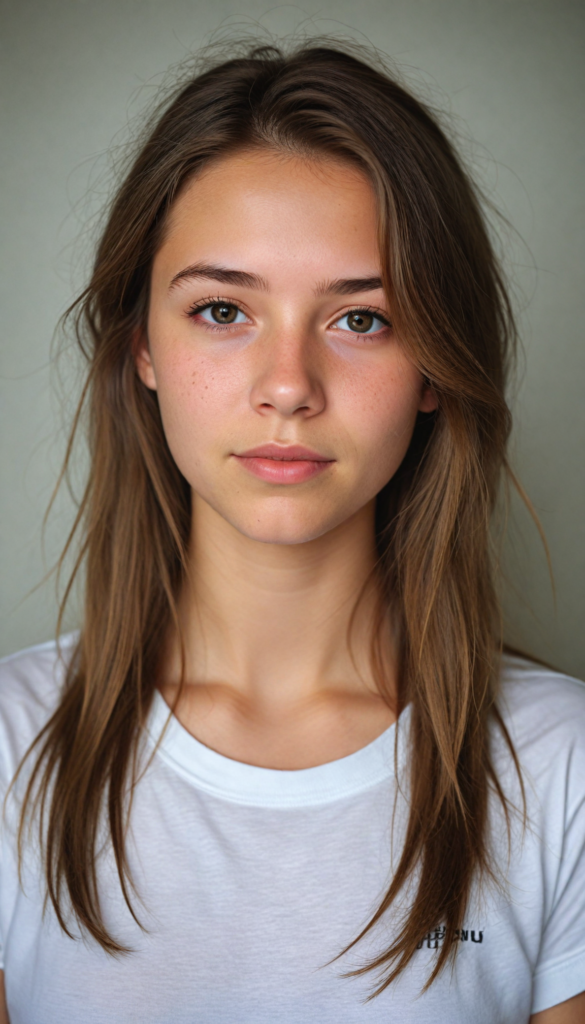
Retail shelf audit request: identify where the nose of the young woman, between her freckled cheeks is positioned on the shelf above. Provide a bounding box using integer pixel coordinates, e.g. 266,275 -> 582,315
250,330 -> 325,419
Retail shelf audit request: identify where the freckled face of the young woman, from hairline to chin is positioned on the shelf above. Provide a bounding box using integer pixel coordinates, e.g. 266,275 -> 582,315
136,152 -> 434,544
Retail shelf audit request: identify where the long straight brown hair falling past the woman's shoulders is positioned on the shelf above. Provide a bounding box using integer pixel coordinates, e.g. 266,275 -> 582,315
20,42 -> 522,994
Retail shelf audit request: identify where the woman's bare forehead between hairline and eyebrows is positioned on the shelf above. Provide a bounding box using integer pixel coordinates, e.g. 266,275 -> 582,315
155,151 -> 379,276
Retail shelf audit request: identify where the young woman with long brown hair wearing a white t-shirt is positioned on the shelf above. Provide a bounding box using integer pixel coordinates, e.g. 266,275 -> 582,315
0,46 -> 585,1024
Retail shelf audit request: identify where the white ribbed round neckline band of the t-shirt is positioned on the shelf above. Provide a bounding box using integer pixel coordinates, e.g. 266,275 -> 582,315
148,690 -> 410,808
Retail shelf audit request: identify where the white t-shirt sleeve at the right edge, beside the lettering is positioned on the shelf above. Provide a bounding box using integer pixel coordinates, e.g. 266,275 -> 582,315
532,733 -> 585,1013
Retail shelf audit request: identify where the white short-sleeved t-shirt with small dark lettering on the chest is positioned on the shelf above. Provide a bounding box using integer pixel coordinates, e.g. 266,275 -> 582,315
0,642 -> 585,1024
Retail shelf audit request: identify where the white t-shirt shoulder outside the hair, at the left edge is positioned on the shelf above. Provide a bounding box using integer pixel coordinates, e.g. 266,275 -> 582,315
0,633 -> 77,774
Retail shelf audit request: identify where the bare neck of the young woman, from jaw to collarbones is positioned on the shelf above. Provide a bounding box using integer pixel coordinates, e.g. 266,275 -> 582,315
171,496 -> 393,710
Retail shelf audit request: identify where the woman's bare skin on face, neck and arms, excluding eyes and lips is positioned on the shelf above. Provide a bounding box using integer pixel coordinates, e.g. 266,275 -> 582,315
0,152 -> 585,1024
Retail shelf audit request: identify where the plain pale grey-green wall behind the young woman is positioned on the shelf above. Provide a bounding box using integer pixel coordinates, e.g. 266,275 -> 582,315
0,0 -> 585,676
